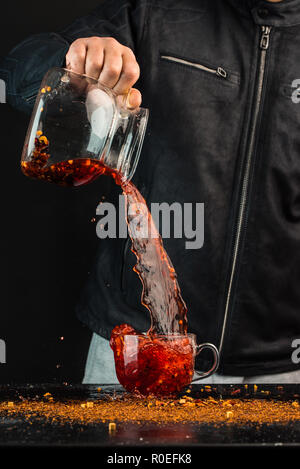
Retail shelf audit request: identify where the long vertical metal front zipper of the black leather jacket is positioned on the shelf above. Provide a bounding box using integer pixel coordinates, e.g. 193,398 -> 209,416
219,26 -> 271,354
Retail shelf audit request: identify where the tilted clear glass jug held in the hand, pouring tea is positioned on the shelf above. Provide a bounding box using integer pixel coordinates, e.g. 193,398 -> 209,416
21,67 -> 149,186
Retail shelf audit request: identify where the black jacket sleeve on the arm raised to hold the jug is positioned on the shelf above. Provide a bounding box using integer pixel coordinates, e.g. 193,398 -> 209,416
0,0 -> 148,113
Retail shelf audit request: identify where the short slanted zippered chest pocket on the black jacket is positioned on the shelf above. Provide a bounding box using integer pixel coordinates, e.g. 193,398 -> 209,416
160,53 -> 240,85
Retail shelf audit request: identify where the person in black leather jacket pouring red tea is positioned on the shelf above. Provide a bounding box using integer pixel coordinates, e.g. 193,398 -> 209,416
0,0 -> 300,383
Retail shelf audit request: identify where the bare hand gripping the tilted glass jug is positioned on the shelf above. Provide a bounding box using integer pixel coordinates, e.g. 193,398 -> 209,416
66,37 -> 142,108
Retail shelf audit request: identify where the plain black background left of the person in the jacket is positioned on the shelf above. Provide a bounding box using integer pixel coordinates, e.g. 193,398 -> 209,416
0,0 -> 105,383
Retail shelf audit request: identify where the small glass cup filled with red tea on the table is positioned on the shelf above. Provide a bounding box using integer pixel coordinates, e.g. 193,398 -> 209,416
110,333 -> 219,396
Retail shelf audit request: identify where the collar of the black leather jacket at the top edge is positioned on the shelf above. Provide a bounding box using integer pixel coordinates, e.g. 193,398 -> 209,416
227,0 -> 300,27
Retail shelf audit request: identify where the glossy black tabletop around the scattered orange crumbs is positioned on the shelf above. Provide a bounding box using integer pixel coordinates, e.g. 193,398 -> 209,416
0,384 -> 300,448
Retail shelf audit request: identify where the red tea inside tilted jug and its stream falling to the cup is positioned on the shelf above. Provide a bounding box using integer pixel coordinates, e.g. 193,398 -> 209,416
21,134 -> 187,335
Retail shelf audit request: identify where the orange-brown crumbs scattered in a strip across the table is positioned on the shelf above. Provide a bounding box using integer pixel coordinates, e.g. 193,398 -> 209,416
0,393 -> 300,431
